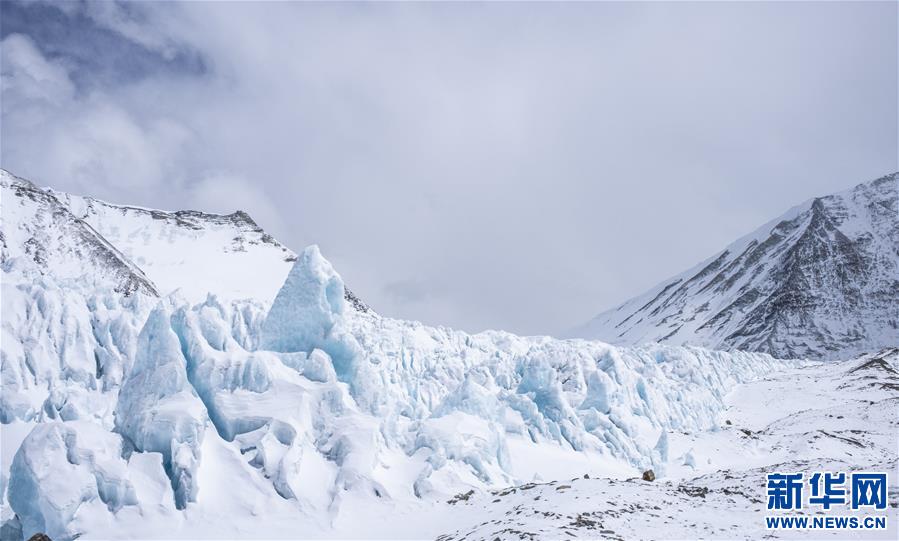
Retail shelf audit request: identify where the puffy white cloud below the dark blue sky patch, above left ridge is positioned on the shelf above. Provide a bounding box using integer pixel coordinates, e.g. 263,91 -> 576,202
2,34 -> 191,199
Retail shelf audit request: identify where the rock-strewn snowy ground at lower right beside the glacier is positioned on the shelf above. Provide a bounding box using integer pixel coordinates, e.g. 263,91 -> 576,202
432,349 -> 899,540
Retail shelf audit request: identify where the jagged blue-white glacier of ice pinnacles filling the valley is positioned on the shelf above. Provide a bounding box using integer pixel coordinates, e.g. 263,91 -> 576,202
0,246 -> 801,539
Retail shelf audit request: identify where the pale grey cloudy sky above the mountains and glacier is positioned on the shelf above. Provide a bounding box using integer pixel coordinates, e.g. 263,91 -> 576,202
0,1 -> 899,334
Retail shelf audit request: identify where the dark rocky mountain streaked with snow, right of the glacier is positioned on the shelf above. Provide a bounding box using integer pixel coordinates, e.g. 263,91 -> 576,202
572,173 -> 899,360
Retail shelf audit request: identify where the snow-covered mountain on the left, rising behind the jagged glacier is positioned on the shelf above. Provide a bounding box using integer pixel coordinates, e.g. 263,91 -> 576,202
0,170 -> 370,311
